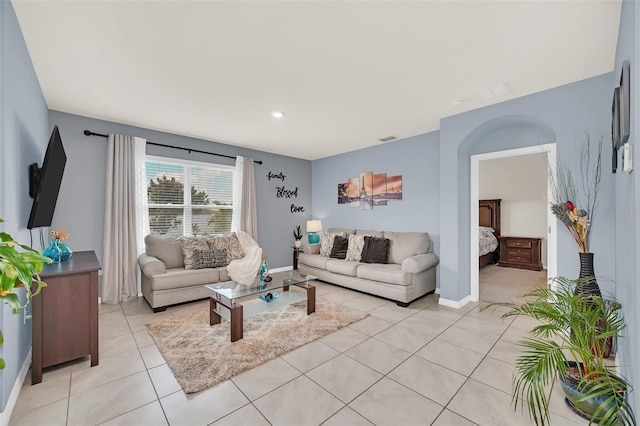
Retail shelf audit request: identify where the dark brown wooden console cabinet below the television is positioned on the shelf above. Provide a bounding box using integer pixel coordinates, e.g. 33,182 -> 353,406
31,251 -> 101,384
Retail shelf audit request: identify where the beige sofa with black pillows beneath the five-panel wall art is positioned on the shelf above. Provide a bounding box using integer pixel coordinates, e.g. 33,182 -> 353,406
298,228 -> 439,307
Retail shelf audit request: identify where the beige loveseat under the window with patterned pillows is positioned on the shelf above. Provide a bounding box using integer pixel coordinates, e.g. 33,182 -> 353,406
138,233 -> 255,312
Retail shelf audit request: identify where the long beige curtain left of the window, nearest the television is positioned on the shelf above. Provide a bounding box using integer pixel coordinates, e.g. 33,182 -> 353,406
101,134 -> 148,304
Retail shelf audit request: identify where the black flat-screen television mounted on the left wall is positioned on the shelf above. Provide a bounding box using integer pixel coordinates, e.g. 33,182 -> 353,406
27,126 -> 67,229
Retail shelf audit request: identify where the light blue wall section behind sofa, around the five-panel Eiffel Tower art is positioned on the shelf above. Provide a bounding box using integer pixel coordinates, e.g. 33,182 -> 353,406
312,132 -> 440,252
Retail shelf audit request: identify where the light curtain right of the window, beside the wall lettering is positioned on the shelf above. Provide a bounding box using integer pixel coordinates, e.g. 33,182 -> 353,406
231,156 -> 258,241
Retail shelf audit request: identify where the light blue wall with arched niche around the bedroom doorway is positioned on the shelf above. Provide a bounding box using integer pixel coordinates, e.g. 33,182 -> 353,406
440,74 -> 615,301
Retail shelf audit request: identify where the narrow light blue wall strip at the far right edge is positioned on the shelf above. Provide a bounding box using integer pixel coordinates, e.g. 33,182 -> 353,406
610,1 -> 640,413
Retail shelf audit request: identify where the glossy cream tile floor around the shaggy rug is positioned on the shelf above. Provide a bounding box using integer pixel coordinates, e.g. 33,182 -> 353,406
9,282 -> 588,426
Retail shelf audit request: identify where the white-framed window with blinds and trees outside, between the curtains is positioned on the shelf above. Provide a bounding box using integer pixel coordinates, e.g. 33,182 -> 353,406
146,156 -> 234,235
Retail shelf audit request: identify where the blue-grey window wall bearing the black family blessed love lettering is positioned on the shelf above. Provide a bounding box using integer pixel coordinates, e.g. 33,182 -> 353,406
47,111 -> 311,268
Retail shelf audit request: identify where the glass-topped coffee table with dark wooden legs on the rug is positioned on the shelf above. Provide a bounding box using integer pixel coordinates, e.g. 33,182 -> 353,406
206,271 -> 318,342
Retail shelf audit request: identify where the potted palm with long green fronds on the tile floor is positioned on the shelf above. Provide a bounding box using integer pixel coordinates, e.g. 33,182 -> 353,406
489,277 -> 635,425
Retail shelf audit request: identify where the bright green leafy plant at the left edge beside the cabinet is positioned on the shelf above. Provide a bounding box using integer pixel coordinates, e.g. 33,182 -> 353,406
0,218 -> 51,369
